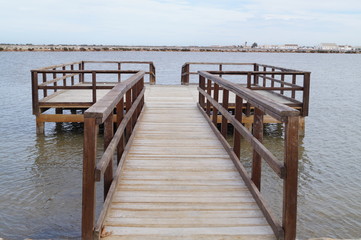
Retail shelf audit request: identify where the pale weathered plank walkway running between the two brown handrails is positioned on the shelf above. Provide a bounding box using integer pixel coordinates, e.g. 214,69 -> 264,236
101,86 -> 275,240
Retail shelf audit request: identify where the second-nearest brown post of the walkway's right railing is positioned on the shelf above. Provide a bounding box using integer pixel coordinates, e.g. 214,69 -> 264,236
251,108 -> 263,191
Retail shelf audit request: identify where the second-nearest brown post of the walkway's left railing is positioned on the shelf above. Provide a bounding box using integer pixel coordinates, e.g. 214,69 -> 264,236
104,113 -> 114,200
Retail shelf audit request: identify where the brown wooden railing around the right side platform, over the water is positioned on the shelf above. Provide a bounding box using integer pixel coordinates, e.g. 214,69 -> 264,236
182,63 -> 310,117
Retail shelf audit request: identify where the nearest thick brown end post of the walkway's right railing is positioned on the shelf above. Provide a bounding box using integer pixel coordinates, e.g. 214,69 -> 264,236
282,116 -> 299,240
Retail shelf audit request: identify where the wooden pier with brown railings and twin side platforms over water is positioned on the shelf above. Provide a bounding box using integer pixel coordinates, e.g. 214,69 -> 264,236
32,62 -> 310,240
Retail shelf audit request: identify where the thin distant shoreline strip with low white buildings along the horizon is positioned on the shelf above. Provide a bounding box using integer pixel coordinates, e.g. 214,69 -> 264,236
0,44 -> 361,54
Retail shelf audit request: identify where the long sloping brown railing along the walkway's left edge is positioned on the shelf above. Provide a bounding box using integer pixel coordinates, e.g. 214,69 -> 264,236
82,71 -> 145,240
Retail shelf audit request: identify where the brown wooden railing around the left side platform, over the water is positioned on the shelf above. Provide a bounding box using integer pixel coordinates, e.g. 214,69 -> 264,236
31,61 -> 156,115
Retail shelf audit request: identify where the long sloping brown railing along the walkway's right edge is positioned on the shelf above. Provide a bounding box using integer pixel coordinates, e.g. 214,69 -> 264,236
198,71 -> 300,240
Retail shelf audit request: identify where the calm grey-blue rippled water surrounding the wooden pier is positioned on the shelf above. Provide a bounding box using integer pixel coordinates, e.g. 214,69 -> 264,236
0,52 -> 361,239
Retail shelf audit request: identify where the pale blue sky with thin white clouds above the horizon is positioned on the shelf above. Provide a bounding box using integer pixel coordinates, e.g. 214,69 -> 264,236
0,0 -> 361,46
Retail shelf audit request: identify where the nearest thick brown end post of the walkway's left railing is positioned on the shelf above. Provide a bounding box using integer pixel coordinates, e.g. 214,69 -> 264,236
82,118 -> 98,240
